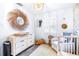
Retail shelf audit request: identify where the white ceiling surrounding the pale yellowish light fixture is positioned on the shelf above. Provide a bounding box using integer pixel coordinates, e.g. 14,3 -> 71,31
20,3 -> 76,13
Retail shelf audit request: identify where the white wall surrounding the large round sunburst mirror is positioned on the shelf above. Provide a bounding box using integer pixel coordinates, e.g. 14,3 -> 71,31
0,3 -> 34,55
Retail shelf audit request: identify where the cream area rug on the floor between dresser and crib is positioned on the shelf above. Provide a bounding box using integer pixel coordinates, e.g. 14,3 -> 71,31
30,44 -> 57,56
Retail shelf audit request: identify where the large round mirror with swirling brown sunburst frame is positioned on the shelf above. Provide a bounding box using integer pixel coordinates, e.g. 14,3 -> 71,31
8,9 -> 29,30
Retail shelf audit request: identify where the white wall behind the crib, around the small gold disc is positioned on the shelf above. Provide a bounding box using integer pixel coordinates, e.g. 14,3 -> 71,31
35,4 -> 74,43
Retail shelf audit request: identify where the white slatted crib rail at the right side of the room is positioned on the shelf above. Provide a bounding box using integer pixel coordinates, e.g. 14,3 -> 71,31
52,36 -> 79,55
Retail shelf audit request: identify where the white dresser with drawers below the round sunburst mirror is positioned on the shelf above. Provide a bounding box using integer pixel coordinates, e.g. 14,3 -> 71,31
8,34 -> 35,56
